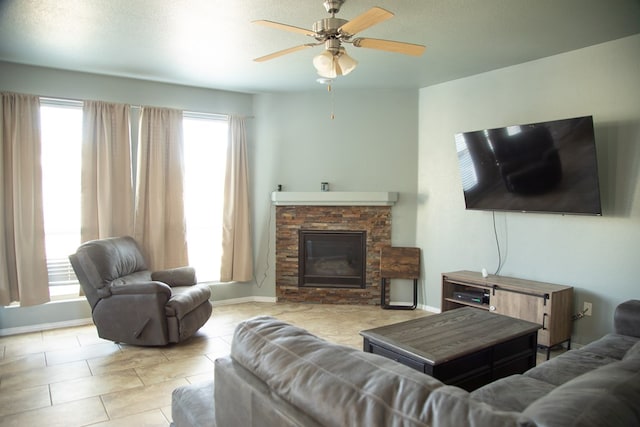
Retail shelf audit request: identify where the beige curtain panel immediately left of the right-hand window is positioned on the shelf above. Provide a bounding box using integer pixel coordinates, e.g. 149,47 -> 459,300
134,107 -> 188,270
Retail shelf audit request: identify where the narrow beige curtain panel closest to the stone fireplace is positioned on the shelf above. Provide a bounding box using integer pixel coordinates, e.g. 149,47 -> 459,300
220,117 -> 253,282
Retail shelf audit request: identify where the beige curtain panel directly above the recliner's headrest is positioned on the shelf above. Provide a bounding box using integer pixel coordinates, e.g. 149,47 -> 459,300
80,101 -> 133,242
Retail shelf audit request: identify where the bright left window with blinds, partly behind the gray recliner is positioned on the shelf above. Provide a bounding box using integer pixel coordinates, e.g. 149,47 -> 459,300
40,100 -> 82,298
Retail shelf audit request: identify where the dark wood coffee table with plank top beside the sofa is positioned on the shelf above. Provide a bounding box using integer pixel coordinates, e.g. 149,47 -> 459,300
360,307 -> 542,391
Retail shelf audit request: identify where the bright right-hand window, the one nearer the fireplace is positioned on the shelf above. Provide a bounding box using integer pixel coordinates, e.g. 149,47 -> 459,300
183,113 -> 229,282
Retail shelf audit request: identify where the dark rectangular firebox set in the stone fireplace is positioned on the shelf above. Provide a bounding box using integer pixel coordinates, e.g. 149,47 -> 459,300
298,230 -> 367,288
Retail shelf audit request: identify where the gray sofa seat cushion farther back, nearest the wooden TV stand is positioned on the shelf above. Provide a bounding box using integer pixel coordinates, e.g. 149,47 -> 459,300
524,350 -> 618,385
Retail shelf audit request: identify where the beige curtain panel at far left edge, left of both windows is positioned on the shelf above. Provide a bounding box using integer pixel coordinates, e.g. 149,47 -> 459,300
0,93 -> 50,306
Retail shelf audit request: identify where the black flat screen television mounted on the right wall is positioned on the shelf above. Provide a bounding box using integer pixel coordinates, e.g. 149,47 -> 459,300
455,116 -> 602,215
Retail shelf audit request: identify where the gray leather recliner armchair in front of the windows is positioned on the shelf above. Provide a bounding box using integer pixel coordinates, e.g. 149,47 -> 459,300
69,236 -> 212,346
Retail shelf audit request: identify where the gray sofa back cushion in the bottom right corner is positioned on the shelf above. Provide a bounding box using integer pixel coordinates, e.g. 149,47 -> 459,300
523,359 -> 640,427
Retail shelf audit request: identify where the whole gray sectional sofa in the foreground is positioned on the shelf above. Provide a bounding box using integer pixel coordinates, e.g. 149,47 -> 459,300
172,300 -> 640,427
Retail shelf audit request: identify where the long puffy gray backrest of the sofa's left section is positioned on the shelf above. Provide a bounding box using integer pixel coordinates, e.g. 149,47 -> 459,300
231,316 -> 532,427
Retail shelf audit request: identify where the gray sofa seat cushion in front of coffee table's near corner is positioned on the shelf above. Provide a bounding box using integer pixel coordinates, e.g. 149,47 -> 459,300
471,374 -> 556,412
